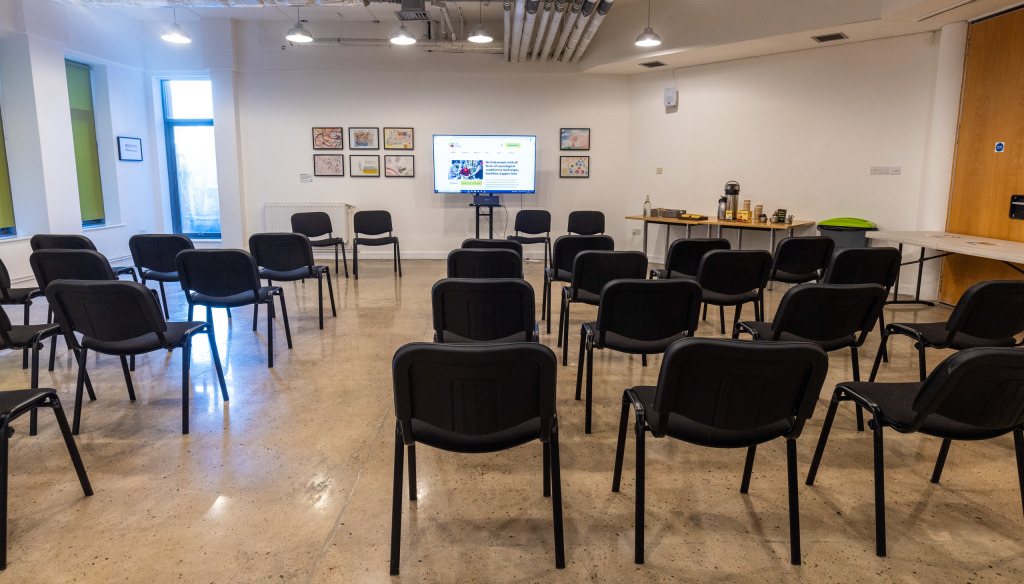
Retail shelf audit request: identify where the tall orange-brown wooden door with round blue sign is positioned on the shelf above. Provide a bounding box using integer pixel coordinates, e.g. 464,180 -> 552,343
939,9 -> 1024,304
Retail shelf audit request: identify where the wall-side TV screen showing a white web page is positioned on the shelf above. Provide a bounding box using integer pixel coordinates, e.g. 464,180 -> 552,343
434,134 -> 537,194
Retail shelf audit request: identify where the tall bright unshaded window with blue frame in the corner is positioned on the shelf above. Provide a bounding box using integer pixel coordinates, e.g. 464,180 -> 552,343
161,79 -> 220,238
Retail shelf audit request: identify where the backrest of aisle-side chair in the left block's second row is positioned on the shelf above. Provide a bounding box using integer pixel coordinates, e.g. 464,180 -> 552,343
175,249 -> 260,297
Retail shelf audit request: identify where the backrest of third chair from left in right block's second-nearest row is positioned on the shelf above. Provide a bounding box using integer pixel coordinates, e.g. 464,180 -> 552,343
765,284 -> 886,346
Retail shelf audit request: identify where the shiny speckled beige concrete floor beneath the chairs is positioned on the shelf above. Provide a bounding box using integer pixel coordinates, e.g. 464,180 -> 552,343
0,260 -> 1024,583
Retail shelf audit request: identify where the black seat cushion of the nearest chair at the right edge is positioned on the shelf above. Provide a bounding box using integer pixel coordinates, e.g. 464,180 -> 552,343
839,381 -> 1013,440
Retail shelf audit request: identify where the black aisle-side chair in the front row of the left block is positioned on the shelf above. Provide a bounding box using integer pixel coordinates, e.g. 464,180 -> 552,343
249,234 -> 338,329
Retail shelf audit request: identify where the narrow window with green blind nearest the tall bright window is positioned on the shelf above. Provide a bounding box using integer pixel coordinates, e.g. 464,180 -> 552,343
65,60 -> 106,226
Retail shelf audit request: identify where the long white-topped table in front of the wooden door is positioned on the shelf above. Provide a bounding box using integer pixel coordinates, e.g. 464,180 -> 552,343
866,232 -> 1024,306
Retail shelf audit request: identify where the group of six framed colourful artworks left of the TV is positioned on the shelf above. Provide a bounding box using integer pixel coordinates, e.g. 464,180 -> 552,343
312,126 -> 416,178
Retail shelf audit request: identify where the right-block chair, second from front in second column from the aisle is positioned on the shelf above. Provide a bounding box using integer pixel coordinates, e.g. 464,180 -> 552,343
558,251 -> 647,365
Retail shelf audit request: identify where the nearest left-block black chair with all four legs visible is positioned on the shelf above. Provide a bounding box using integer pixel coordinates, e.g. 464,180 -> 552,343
46,280 -> 227,434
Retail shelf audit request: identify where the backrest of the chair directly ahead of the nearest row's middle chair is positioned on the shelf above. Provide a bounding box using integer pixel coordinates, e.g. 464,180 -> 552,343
597,278 -> 700,345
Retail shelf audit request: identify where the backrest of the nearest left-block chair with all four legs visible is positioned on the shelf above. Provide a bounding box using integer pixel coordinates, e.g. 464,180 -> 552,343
46,280 -> 167,345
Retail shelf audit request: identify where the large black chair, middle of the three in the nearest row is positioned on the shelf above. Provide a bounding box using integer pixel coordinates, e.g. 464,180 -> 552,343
611,338 -> 828,566
